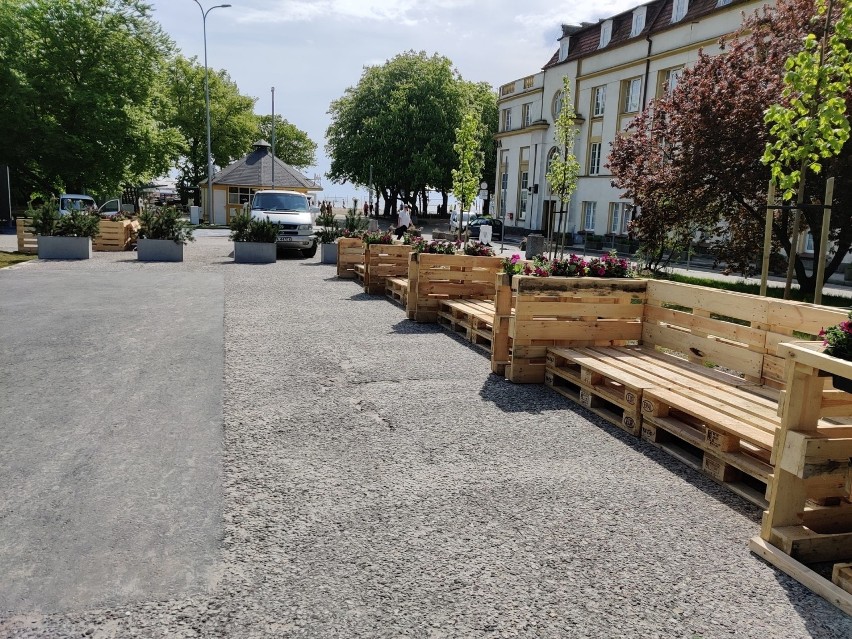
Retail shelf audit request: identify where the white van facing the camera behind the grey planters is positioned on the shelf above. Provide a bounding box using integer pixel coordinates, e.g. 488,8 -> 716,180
251,189 -> 317,258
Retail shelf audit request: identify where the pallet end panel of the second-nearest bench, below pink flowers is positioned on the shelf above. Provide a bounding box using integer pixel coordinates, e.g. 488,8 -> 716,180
408,253 -> 503,322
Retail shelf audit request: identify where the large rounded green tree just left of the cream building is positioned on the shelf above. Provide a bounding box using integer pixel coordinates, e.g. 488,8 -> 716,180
326,51 -> 497,215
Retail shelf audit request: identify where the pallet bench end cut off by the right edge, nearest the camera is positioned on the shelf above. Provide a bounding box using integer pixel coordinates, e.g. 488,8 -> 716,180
749,342 -> 852,615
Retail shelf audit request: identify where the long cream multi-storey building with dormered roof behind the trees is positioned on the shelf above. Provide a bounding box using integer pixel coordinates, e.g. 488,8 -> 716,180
495,0 -> 769,242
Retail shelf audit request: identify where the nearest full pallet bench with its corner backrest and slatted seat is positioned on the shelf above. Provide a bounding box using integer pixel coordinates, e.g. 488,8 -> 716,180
492,277 -> 845,506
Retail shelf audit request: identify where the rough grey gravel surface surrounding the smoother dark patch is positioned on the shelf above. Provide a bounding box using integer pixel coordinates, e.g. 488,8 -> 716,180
0,238 -> 852,639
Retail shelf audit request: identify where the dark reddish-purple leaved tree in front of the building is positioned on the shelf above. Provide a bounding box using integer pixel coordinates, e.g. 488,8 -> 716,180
608,0 -> 852,294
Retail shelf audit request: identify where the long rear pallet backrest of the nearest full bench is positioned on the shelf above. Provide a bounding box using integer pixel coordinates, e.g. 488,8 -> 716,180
642,281 -> 846,388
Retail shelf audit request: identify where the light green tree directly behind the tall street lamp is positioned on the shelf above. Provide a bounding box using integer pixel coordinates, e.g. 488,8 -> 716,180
163,56 -> 259,201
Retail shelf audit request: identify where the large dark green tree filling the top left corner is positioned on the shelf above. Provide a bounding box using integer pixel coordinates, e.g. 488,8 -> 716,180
0,0 -> 180,200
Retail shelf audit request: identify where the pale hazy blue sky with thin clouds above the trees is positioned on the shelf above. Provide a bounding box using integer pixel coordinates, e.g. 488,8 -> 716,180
149,0 -> 642,199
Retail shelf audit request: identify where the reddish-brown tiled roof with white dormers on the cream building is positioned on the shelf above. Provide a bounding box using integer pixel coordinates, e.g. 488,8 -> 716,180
543,0 -> 749,69
